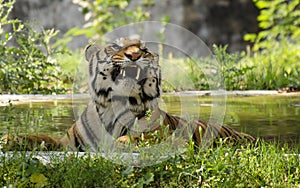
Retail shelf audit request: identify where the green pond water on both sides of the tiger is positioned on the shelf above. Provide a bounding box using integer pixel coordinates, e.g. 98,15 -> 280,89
0,95 -> 300,143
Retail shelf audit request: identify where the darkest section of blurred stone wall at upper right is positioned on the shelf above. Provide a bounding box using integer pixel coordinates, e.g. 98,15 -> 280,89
183,0 -> 259,51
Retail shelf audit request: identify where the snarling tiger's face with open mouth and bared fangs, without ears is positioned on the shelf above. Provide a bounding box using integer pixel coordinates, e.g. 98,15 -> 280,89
108,39 -> 161,107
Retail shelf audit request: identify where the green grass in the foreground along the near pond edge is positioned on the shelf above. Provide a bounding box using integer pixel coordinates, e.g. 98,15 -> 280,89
0,141 -> 300,187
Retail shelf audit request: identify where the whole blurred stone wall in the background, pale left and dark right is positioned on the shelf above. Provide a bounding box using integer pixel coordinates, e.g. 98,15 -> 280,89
13,0 -> 258,51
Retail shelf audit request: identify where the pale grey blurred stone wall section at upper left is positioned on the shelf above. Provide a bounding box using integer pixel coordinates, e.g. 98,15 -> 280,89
12,0 -> 87,49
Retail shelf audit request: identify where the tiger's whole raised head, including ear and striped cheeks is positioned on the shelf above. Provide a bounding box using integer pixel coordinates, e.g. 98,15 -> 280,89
85,38 -> 161,120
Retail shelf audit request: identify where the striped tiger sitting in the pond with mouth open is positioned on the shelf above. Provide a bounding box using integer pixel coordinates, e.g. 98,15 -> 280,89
2,38 -> 255,151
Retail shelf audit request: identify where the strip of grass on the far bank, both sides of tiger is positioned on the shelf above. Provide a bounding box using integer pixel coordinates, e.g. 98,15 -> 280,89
57,44 -> 300,92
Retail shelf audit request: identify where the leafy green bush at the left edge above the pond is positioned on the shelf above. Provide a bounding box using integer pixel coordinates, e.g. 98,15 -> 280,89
0,0 -> 68,94
